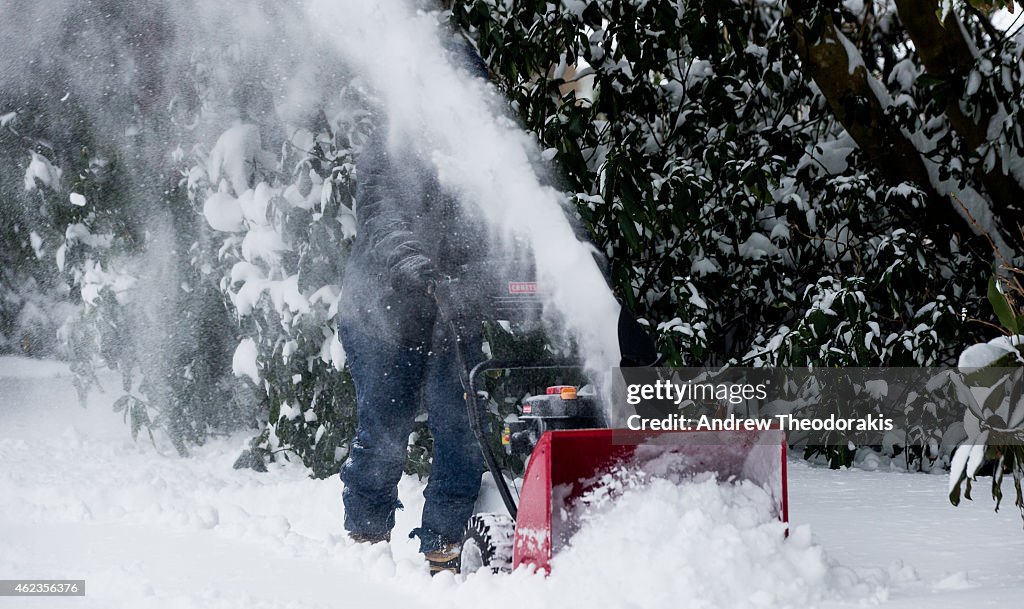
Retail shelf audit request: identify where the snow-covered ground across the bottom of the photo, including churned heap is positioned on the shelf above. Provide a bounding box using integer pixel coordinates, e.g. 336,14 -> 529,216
0,358 -> 1024,609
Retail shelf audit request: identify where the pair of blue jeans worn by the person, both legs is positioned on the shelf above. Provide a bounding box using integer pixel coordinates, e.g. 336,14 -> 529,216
338,319 -> 483,552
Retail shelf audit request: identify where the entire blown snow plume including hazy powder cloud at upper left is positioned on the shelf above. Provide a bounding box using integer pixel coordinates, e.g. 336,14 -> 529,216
0,0 -> 618,409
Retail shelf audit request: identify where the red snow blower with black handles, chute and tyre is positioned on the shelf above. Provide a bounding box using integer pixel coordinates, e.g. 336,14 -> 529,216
434,265 -> 788,573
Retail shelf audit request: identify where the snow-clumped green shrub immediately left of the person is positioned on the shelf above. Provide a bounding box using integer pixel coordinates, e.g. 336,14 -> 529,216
189,105 -> 365,476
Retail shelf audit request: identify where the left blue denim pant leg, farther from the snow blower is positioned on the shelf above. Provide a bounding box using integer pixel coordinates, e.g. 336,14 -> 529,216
339,323 -> 427,536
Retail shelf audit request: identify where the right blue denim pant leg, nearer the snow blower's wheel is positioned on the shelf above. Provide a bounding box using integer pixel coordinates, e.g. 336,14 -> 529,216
419,339 -> 483,552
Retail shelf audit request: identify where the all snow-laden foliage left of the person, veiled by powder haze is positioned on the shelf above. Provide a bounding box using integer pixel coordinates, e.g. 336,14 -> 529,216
0,0 -> 361,473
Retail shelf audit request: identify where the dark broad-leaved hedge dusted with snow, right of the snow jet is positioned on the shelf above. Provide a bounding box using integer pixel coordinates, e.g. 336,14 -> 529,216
452,0 -> 1024,466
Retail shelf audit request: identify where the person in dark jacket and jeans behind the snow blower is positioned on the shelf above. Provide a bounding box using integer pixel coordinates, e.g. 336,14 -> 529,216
338,39 -> 487,573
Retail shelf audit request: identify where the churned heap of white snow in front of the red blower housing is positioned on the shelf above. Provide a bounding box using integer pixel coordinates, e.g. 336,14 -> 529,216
552,460 -> 885,608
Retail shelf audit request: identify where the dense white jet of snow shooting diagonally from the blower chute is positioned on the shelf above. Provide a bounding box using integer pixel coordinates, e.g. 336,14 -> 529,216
308,0 -> 620,395
